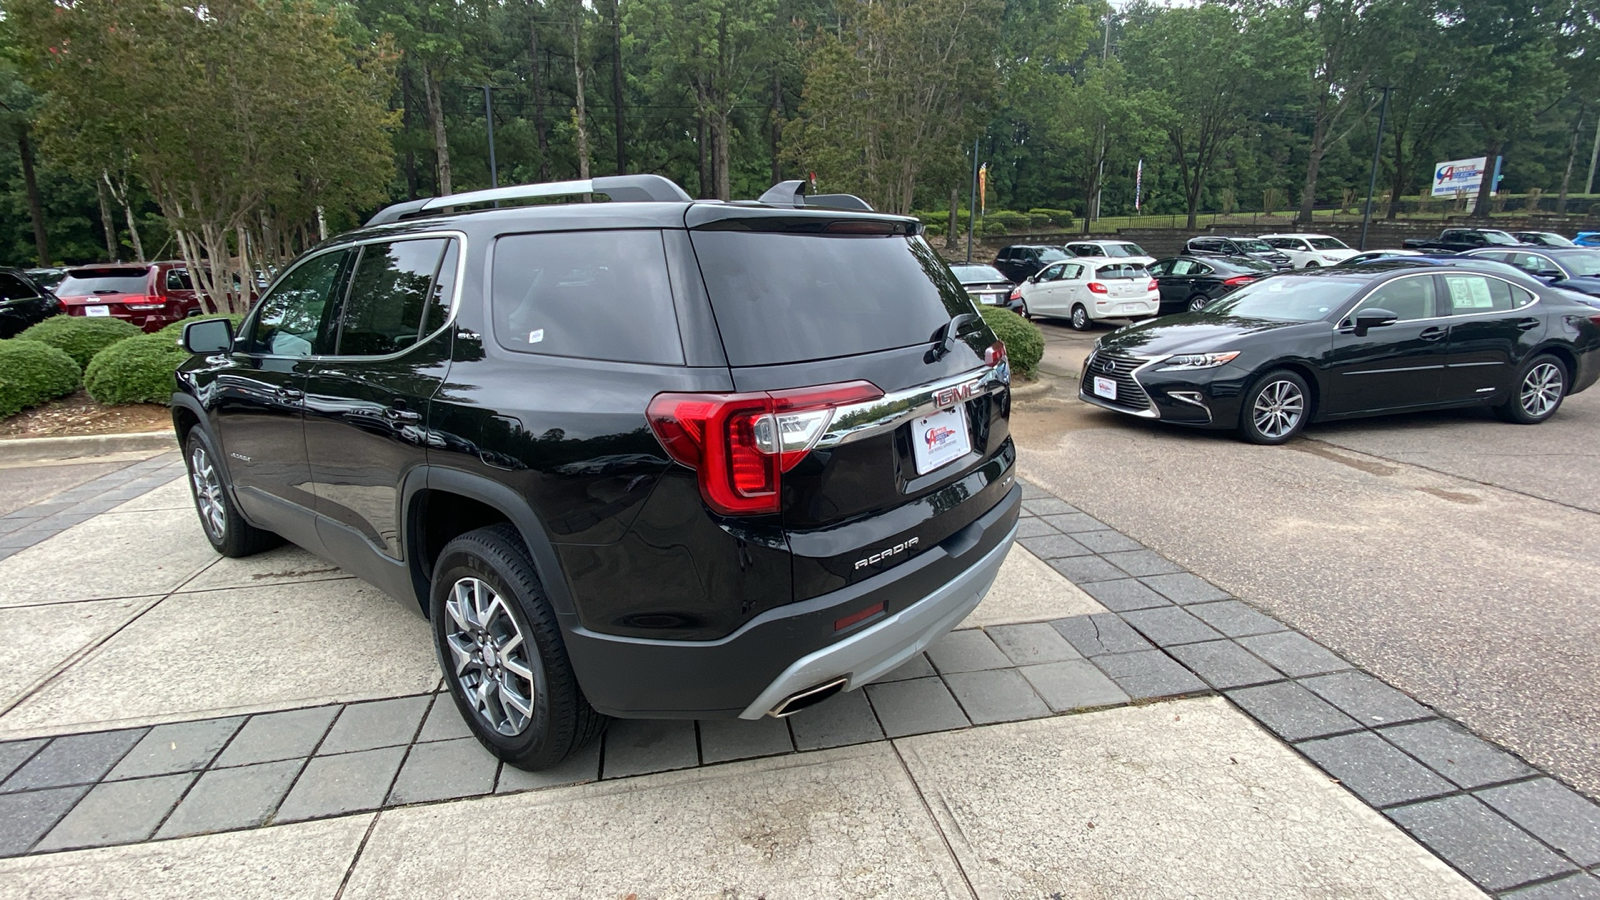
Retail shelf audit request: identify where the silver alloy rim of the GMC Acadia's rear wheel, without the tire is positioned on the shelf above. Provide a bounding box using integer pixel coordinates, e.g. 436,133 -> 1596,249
445,578 -> 534,737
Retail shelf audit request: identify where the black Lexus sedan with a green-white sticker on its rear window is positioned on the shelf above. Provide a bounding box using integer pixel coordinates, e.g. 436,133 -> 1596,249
1078,259 -> 1600,444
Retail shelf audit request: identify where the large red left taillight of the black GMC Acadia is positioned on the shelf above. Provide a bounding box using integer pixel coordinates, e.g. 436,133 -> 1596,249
646,381 -> 883,516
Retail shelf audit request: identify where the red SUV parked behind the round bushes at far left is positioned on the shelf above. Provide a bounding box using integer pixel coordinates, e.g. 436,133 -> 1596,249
56,263 -> 200,331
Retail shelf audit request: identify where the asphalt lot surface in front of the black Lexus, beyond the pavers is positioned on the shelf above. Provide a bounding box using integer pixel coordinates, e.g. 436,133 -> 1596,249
1013,315 -> 1600,796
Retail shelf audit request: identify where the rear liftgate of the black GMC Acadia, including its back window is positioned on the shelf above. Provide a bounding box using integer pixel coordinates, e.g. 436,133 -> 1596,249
686,205 -> 1014,601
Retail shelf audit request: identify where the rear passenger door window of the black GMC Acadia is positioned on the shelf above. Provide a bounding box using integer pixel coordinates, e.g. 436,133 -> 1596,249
333,237 -> 453,356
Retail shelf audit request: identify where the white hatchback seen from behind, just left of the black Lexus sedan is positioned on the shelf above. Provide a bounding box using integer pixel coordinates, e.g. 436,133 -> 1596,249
1016,258 -> 1162,331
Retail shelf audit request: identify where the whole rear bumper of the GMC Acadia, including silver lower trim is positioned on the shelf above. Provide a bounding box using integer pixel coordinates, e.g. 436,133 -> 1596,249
565,472 -> 1022,719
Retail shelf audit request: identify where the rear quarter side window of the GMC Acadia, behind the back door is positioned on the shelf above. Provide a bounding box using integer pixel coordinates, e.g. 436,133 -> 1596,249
490,231 -> 683,365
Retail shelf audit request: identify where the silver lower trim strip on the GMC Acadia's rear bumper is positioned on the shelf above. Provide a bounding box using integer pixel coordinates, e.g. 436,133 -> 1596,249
739,525 -> 1016,719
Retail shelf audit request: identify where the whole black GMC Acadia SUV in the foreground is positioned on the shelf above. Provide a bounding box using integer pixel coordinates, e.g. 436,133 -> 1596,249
173,176 -> 1021,767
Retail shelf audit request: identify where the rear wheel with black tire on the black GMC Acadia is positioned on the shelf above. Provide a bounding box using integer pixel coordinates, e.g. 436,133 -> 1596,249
429,525 -> 606,770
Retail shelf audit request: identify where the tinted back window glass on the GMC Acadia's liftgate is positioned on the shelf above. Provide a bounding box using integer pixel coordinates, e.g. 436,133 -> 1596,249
691,231 -> 966,365
